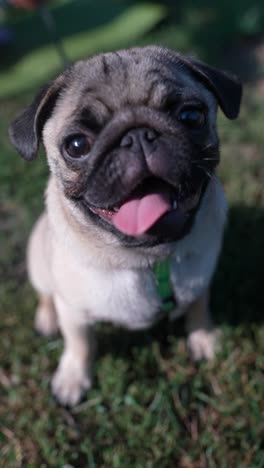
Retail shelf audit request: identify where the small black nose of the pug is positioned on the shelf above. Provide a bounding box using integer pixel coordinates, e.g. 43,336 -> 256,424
120,128 -> 158,151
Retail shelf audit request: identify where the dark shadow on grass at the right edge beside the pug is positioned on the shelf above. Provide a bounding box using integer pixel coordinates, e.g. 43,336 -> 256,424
212,205 -> 264,325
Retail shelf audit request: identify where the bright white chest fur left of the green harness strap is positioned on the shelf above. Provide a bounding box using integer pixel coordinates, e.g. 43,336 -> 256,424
53,245 -> 161,329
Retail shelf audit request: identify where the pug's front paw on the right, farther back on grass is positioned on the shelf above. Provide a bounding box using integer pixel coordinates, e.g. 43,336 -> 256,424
187,329 -> 220,361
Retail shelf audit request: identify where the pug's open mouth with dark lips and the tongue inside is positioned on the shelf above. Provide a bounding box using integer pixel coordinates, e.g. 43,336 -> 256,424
86,178 -> 203,237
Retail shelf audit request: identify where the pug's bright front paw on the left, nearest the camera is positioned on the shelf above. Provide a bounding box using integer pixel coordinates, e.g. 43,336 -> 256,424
51,353 -> 91,407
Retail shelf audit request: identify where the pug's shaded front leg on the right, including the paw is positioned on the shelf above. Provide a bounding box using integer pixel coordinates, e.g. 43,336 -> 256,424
185,291 -> 218,361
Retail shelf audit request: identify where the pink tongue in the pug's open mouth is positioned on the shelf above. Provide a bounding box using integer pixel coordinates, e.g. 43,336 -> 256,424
112,193 -> 171,236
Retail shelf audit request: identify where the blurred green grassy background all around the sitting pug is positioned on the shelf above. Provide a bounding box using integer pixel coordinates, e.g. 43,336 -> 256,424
0,0 -> 264,468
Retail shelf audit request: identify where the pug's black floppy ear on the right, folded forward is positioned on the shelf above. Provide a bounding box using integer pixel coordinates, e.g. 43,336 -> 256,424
183,58 -> 242,119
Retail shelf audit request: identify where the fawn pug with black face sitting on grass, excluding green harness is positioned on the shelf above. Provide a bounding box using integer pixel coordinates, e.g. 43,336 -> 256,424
10,46 -> 242,406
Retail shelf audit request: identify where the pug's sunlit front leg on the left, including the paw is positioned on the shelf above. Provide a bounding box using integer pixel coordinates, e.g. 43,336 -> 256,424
51,296 -> 93,406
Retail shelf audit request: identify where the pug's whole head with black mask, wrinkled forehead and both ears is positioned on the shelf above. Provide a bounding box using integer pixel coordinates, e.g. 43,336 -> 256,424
10,47 -> 241,246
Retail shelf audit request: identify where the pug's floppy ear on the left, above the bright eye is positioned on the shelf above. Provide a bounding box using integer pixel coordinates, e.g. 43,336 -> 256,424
9,75 -> 65,161
